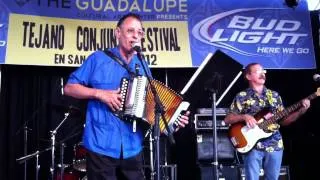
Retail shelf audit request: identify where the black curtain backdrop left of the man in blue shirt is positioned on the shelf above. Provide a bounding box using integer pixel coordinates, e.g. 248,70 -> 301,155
0,65 -> 85,179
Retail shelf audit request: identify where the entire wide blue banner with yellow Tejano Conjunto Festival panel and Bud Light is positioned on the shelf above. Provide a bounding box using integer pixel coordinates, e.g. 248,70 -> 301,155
0,0 -> 316,69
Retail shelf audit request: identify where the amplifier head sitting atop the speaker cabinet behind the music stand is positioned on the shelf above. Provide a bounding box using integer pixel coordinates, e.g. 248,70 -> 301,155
194,114 -> 229,130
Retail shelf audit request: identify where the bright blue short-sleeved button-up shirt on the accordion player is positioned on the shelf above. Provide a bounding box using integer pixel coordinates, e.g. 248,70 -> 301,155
68,48 -> 151,158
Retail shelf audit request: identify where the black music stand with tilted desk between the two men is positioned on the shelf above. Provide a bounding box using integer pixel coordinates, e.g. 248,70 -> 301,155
180,50 -> 243,180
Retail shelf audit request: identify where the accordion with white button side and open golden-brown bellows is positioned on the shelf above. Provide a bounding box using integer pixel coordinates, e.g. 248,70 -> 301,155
117,76 -> 190,135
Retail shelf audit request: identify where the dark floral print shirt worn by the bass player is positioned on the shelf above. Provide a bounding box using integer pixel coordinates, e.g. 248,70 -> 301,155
228,87 -> 284,152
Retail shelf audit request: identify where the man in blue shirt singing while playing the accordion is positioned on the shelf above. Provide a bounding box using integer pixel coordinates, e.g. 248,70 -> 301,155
64,13 -> 189,180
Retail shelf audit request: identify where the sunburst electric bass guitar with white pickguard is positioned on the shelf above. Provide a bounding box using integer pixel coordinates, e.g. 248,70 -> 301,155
228,88 -> 320,153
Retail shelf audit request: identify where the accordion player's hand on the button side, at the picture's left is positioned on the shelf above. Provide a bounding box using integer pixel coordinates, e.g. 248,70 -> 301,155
96,89 -> 121,112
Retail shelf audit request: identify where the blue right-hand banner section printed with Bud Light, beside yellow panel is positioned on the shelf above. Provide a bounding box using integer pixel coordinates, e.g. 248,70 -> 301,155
189,0 -> 316,69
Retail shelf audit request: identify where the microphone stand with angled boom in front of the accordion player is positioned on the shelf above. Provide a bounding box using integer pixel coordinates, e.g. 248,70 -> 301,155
136,50 -> 174,180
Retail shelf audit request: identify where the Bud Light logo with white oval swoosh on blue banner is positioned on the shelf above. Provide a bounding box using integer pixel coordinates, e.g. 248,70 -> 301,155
192,8 -> 308,56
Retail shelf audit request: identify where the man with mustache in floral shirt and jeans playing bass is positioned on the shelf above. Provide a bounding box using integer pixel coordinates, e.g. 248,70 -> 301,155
224,63 -> 310,180
